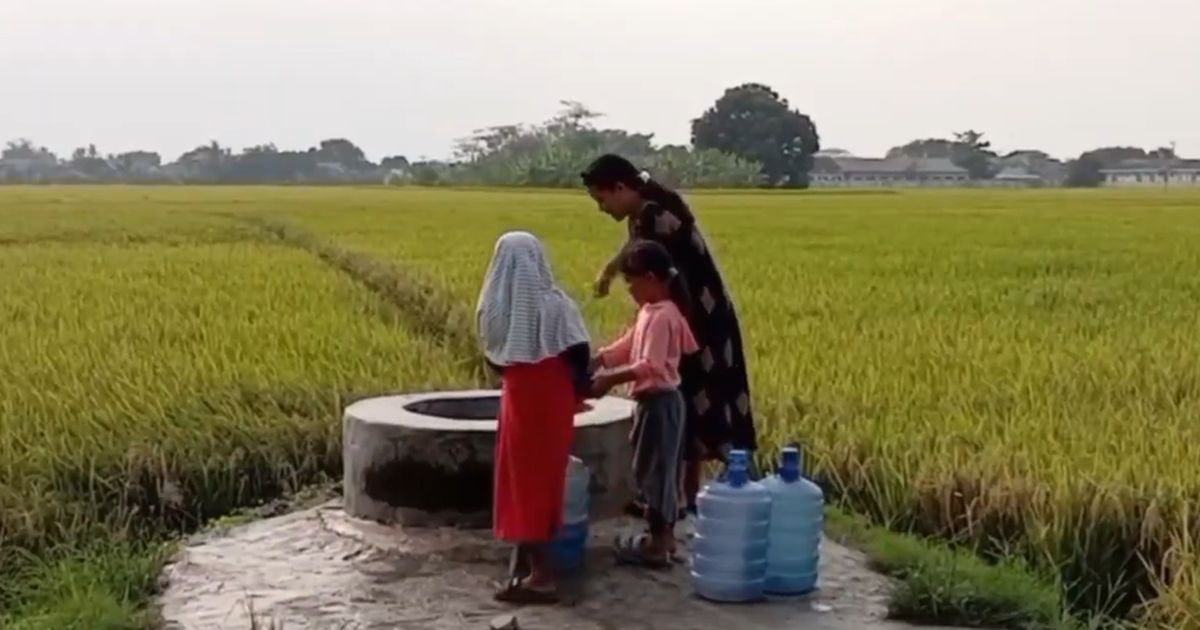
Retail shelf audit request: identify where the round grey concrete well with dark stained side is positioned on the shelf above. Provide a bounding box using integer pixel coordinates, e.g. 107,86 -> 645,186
342,390 -> 634,527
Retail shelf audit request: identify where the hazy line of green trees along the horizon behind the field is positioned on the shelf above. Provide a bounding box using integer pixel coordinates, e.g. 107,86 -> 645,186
0,83 -> 1174,187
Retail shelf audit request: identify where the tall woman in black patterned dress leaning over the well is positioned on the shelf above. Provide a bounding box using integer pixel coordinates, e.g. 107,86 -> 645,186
582,155 -> 757,510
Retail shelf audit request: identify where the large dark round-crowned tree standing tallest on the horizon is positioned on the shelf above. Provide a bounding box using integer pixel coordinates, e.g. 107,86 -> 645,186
691,83 -> 821,186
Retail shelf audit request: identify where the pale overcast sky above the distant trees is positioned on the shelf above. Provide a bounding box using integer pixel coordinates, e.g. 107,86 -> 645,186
0,0 -> 1200,160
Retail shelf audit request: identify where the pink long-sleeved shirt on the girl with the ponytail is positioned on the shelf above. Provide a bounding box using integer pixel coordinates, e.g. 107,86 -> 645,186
600,300 -> 700,395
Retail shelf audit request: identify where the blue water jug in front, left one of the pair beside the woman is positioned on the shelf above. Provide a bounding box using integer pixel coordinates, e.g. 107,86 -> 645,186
691,450 -> 770,601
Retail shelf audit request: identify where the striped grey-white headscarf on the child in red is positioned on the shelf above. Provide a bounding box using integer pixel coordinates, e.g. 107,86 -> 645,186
475,232 -> 590,366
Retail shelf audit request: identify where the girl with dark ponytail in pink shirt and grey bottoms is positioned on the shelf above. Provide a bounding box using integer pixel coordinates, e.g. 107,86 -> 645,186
594,241 -> 698,566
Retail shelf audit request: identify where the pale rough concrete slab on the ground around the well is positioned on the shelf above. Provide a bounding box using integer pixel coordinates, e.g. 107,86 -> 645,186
158,503 -> 969,630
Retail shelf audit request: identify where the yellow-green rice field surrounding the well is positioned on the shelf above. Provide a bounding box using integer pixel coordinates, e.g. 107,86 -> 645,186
0,186 -> 1200,628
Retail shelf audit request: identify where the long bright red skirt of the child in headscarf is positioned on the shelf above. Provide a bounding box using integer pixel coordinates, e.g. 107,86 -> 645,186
493,356 -> 577,542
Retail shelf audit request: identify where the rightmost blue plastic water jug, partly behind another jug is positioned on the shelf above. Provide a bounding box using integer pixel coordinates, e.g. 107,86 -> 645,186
763,448 -> 824,595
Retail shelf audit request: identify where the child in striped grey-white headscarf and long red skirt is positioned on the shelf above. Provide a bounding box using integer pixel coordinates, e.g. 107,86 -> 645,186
476,232 -> 590,604
